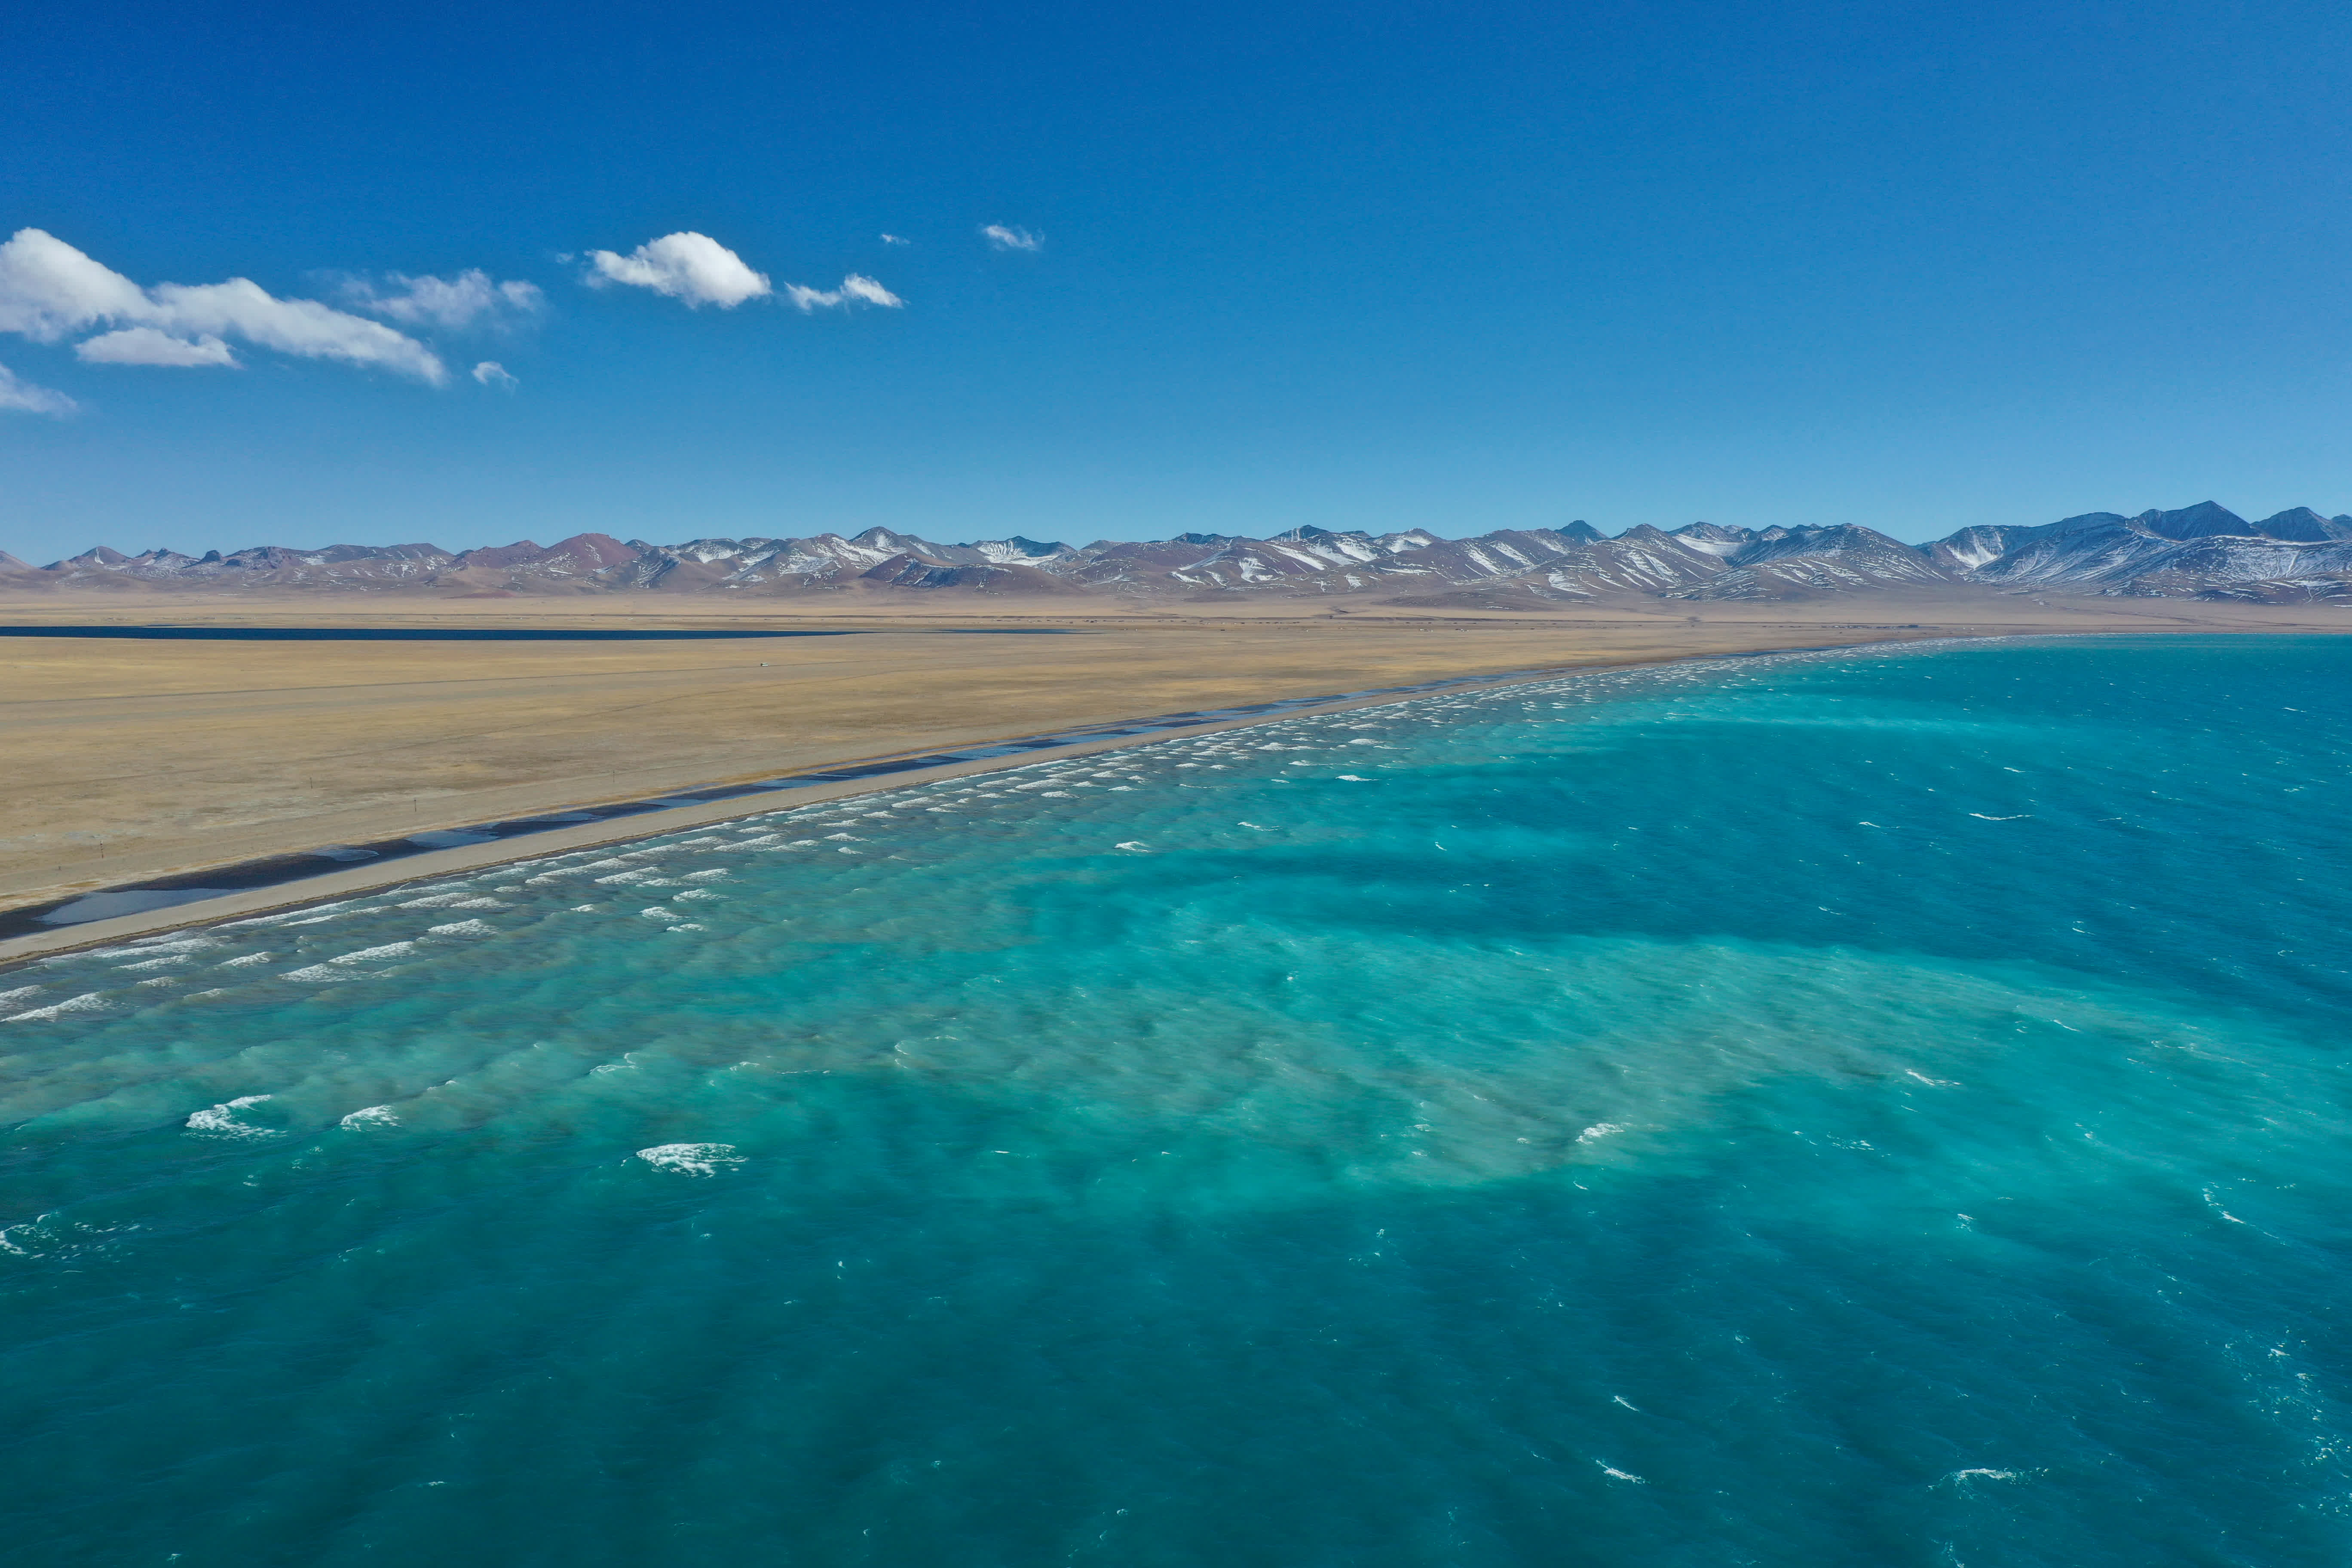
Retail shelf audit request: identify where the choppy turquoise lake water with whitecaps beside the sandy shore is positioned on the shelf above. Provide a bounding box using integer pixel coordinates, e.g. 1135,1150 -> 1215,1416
0,637 -> 2352,1568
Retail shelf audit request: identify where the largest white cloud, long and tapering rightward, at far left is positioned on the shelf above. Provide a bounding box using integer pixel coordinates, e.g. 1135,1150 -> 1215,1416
0,228 -> 449,386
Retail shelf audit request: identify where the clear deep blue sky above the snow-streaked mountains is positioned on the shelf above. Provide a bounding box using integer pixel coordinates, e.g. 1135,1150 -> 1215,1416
0,0 -> 2352,560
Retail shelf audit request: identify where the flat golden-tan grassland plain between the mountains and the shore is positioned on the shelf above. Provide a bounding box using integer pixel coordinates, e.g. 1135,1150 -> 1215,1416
0,595 -> 2352,907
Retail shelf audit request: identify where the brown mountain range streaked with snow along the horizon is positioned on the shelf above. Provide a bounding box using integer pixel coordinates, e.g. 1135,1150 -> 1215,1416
0,501 -> 2352,609
